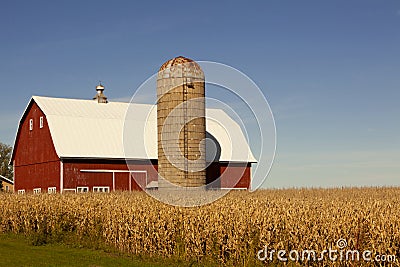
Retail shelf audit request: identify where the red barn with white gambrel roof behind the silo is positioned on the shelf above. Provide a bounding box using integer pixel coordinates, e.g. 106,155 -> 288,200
11,96 -> 255,193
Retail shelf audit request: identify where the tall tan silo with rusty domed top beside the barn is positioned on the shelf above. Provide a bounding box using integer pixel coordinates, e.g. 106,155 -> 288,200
157,56 -> 206,189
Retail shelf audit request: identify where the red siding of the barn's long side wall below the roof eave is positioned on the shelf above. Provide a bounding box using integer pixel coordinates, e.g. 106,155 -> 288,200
63,159 -> 251,191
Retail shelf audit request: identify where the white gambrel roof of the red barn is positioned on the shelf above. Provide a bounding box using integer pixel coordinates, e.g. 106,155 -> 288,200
28,96 -> 256,162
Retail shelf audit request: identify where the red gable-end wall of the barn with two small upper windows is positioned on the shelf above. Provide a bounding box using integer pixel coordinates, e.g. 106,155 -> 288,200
14,102 -> 60,192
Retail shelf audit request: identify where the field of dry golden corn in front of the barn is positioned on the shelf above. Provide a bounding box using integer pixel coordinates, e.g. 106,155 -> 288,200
0,188 -> 400,266
